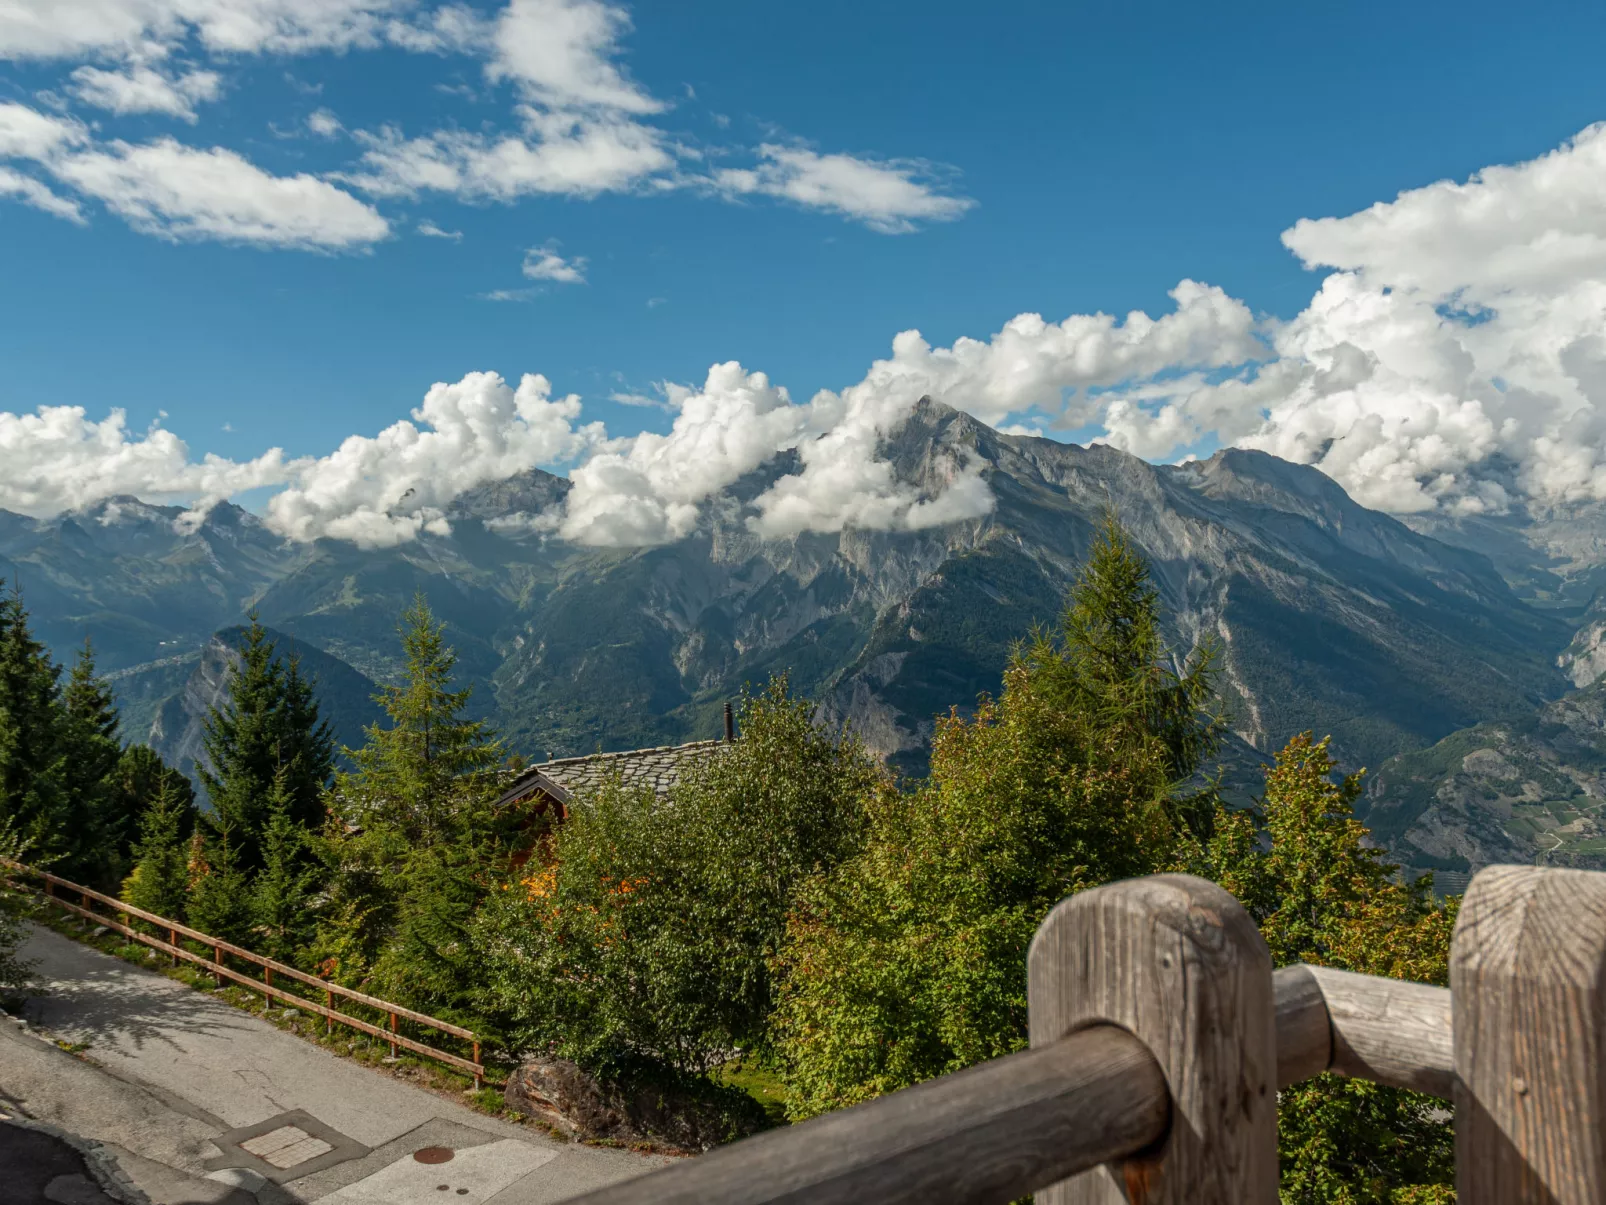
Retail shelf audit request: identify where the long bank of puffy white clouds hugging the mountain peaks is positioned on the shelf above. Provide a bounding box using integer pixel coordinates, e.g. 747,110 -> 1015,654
0,122 -> 1606,546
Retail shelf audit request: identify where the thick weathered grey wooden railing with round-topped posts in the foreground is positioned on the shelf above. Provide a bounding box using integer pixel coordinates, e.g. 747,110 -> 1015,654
570,866 -> 1606,1205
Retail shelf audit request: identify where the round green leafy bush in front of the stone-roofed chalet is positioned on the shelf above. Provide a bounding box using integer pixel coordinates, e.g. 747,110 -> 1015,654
475,678 -> 893,1075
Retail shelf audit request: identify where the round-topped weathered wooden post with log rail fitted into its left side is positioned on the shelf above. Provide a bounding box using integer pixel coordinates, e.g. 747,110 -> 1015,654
1028,874 -> 1277,1205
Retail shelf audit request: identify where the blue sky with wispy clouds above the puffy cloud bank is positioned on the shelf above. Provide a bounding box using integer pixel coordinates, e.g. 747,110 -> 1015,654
0,0 -> 1606,546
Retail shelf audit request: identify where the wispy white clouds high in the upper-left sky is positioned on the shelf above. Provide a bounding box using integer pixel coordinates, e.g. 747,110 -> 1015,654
0,0 -> 972,252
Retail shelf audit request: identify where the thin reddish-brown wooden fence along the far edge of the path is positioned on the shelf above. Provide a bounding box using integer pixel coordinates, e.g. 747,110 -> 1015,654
0,858 -> 485,1088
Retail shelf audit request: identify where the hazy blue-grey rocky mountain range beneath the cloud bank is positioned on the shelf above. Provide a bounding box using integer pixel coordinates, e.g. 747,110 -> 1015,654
12,402 -> 1606,869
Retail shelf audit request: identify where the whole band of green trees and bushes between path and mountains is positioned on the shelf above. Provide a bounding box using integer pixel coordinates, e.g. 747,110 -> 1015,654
0,513 -> 1453,1202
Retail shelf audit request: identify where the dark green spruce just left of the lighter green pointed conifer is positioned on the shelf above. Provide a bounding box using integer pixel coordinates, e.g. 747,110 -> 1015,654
198,623 -> 334,871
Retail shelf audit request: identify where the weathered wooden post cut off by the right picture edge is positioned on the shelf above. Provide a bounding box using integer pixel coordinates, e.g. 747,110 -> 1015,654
1450,866 -> 1606,1205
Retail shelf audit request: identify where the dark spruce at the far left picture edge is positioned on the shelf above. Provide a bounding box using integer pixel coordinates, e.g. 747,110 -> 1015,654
0,582 -> 69,869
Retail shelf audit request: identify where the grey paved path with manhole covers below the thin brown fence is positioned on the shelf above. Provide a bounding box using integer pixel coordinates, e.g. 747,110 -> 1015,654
0,927 -> 660,1205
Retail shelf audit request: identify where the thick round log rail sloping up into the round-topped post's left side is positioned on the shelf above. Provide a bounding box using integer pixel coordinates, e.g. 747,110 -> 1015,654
569,1025 -> 1169,1205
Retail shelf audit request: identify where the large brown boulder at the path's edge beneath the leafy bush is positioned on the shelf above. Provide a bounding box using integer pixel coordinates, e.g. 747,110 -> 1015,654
503,1057 -> 766,1152
